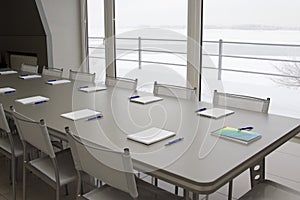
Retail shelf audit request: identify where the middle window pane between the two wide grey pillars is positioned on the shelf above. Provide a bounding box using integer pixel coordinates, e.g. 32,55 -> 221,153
115,0 -> 187,92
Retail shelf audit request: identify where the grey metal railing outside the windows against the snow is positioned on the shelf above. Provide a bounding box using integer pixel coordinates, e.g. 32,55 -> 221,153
89,37 -> 300,80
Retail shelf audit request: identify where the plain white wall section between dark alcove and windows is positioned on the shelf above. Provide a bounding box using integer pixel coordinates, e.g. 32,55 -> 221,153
39,0 -> 82,76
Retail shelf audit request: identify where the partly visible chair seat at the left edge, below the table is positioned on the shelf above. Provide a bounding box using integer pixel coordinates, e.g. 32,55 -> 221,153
0,135 -> 23,157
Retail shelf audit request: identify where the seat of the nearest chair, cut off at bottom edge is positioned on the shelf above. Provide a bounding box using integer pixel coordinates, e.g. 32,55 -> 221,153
82,178 -> 183,200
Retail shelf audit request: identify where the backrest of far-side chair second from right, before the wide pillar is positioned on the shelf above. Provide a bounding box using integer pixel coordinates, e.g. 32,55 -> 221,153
153,81 -> 197,100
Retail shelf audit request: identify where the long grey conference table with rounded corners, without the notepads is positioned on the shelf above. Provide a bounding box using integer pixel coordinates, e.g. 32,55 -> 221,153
0,74 -> 300,199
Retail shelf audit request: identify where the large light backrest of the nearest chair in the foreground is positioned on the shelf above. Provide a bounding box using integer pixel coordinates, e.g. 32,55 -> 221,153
66,127 -> 138,198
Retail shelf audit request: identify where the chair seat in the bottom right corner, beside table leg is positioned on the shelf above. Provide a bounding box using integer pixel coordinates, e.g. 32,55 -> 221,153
239,180 -> 300,200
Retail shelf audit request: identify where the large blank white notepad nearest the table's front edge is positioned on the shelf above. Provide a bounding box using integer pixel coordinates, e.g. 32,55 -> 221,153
127,127 -> 176,145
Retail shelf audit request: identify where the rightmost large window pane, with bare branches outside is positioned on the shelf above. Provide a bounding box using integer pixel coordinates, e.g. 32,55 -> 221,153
202,0 -> 300,117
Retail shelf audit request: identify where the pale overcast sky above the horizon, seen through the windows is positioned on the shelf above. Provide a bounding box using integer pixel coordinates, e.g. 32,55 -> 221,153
88,0 -> 300,35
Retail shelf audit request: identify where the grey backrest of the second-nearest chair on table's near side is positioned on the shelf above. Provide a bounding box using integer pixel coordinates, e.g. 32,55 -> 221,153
11,107 -> 55,158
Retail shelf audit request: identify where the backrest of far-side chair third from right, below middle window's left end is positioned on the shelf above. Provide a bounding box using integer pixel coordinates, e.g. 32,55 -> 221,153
105,76 -> 138,90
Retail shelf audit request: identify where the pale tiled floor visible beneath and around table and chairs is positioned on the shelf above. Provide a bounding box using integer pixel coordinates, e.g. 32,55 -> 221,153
0,139 -> 300,200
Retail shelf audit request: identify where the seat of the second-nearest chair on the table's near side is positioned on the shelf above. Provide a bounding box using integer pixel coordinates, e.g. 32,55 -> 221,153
29,149 -> 77,186
